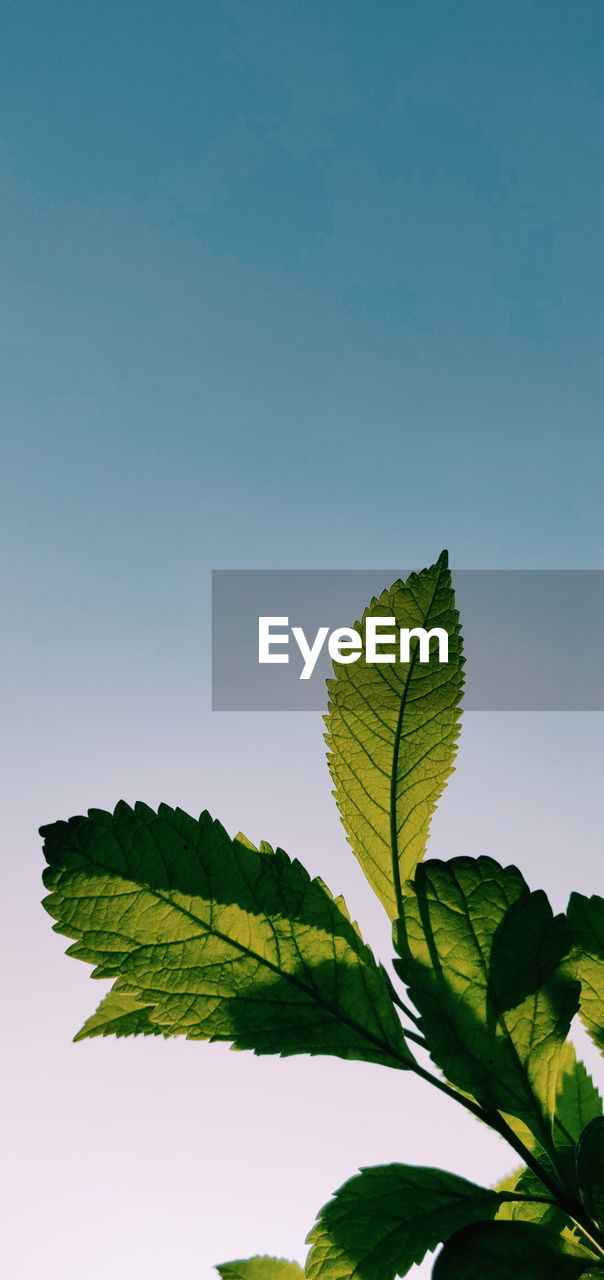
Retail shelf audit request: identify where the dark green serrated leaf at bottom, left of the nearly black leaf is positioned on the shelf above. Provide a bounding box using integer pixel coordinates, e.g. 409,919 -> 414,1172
306,1165 -> 500,1280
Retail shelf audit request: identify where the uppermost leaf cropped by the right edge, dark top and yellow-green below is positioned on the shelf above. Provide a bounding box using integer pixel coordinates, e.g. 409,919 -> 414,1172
567,893 -> 604,1053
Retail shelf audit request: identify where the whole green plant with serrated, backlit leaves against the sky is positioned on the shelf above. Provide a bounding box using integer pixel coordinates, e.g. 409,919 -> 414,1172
42,553 -> 604,1280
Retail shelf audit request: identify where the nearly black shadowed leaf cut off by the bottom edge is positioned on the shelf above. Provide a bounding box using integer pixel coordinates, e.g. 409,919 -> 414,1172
433,1222 -> 594,1280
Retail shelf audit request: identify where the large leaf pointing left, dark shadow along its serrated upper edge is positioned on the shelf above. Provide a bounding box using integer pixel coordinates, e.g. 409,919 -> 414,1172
42,803 -> 412,1068
